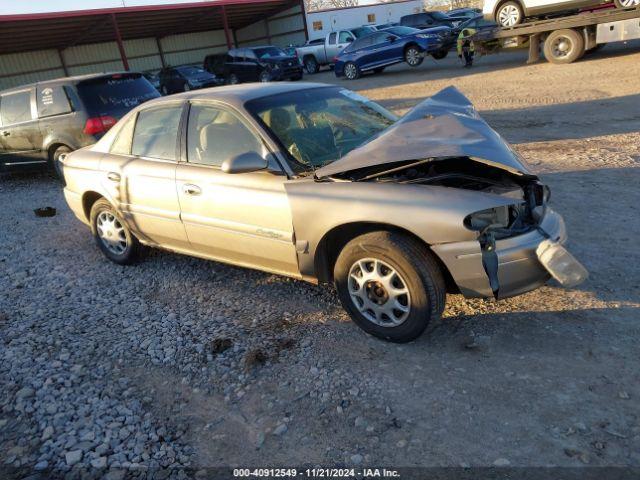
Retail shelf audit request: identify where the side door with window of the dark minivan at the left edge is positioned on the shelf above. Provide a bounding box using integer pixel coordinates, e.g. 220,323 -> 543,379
0,88 -> 47,167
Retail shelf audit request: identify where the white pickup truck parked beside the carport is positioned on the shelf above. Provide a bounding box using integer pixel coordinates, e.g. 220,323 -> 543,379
296,26 -> 375,73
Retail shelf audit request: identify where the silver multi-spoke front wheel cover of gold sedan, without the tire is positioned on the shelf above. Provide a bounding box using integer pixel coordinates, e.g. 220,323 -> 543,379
349,258 -> 411,327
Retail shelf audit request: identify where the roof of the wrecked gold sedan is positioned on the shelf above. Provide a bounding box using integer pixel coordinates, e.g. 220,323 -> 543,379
143,82 -> 335,108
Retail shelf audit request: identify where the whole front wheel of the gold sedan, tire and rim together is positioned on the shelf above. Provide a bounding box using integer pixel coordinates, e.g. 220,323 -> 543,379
334,231 -> 445,343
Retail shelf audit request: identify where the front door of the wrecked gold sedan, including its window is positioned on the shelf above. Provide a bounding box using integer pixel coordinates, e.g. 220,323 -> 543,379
176,103 -> 299,276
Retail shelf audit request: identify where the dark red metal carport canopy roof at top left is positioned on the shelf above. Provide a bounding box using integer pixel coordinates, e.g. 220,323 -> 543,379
0,0 -> 306,56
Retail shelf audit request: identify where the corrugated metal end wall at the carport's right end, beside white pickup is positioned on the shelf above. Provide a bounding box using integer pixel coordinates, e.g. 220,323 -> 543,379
236,5 -> 306,47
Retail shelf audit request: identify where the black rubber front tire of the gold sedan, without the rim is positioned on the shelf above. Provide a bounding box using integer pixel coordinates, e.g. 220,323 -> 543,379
334,231 -> 446,343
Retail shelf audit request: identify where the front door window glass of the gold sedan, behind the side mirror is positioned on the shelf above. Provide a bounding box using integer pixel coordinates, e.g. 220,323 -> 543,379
187,105 -> 262,167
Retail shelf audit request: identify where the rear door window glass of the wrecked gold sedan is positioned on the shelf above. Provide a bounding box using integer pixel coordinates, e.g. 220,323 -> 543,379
131,105 -> 182,160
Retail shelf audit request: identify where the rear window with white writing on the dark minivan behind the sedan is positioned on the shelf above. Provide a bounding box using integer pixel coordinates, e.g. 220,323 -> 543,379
78,74 -> 160,114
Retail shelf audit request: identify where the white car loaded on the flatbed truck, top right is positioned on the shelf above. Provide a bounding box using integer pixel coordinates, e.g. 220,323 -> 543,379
482,0 -> 640,27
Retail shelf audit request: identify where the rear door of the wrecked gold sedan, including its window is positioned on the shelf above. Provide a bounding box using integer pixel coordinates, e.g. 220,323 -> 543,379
100,102 -> 189,251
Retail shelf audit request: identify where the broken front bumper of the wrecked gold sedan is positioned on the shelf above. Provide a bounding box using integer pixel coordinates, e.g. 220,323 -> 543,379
431,209 -> 567,298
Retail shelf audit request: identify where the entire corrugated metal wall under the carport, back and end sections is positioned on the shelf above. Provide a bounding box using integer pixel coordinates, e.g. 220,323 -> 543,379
0,6 -> 305,90
